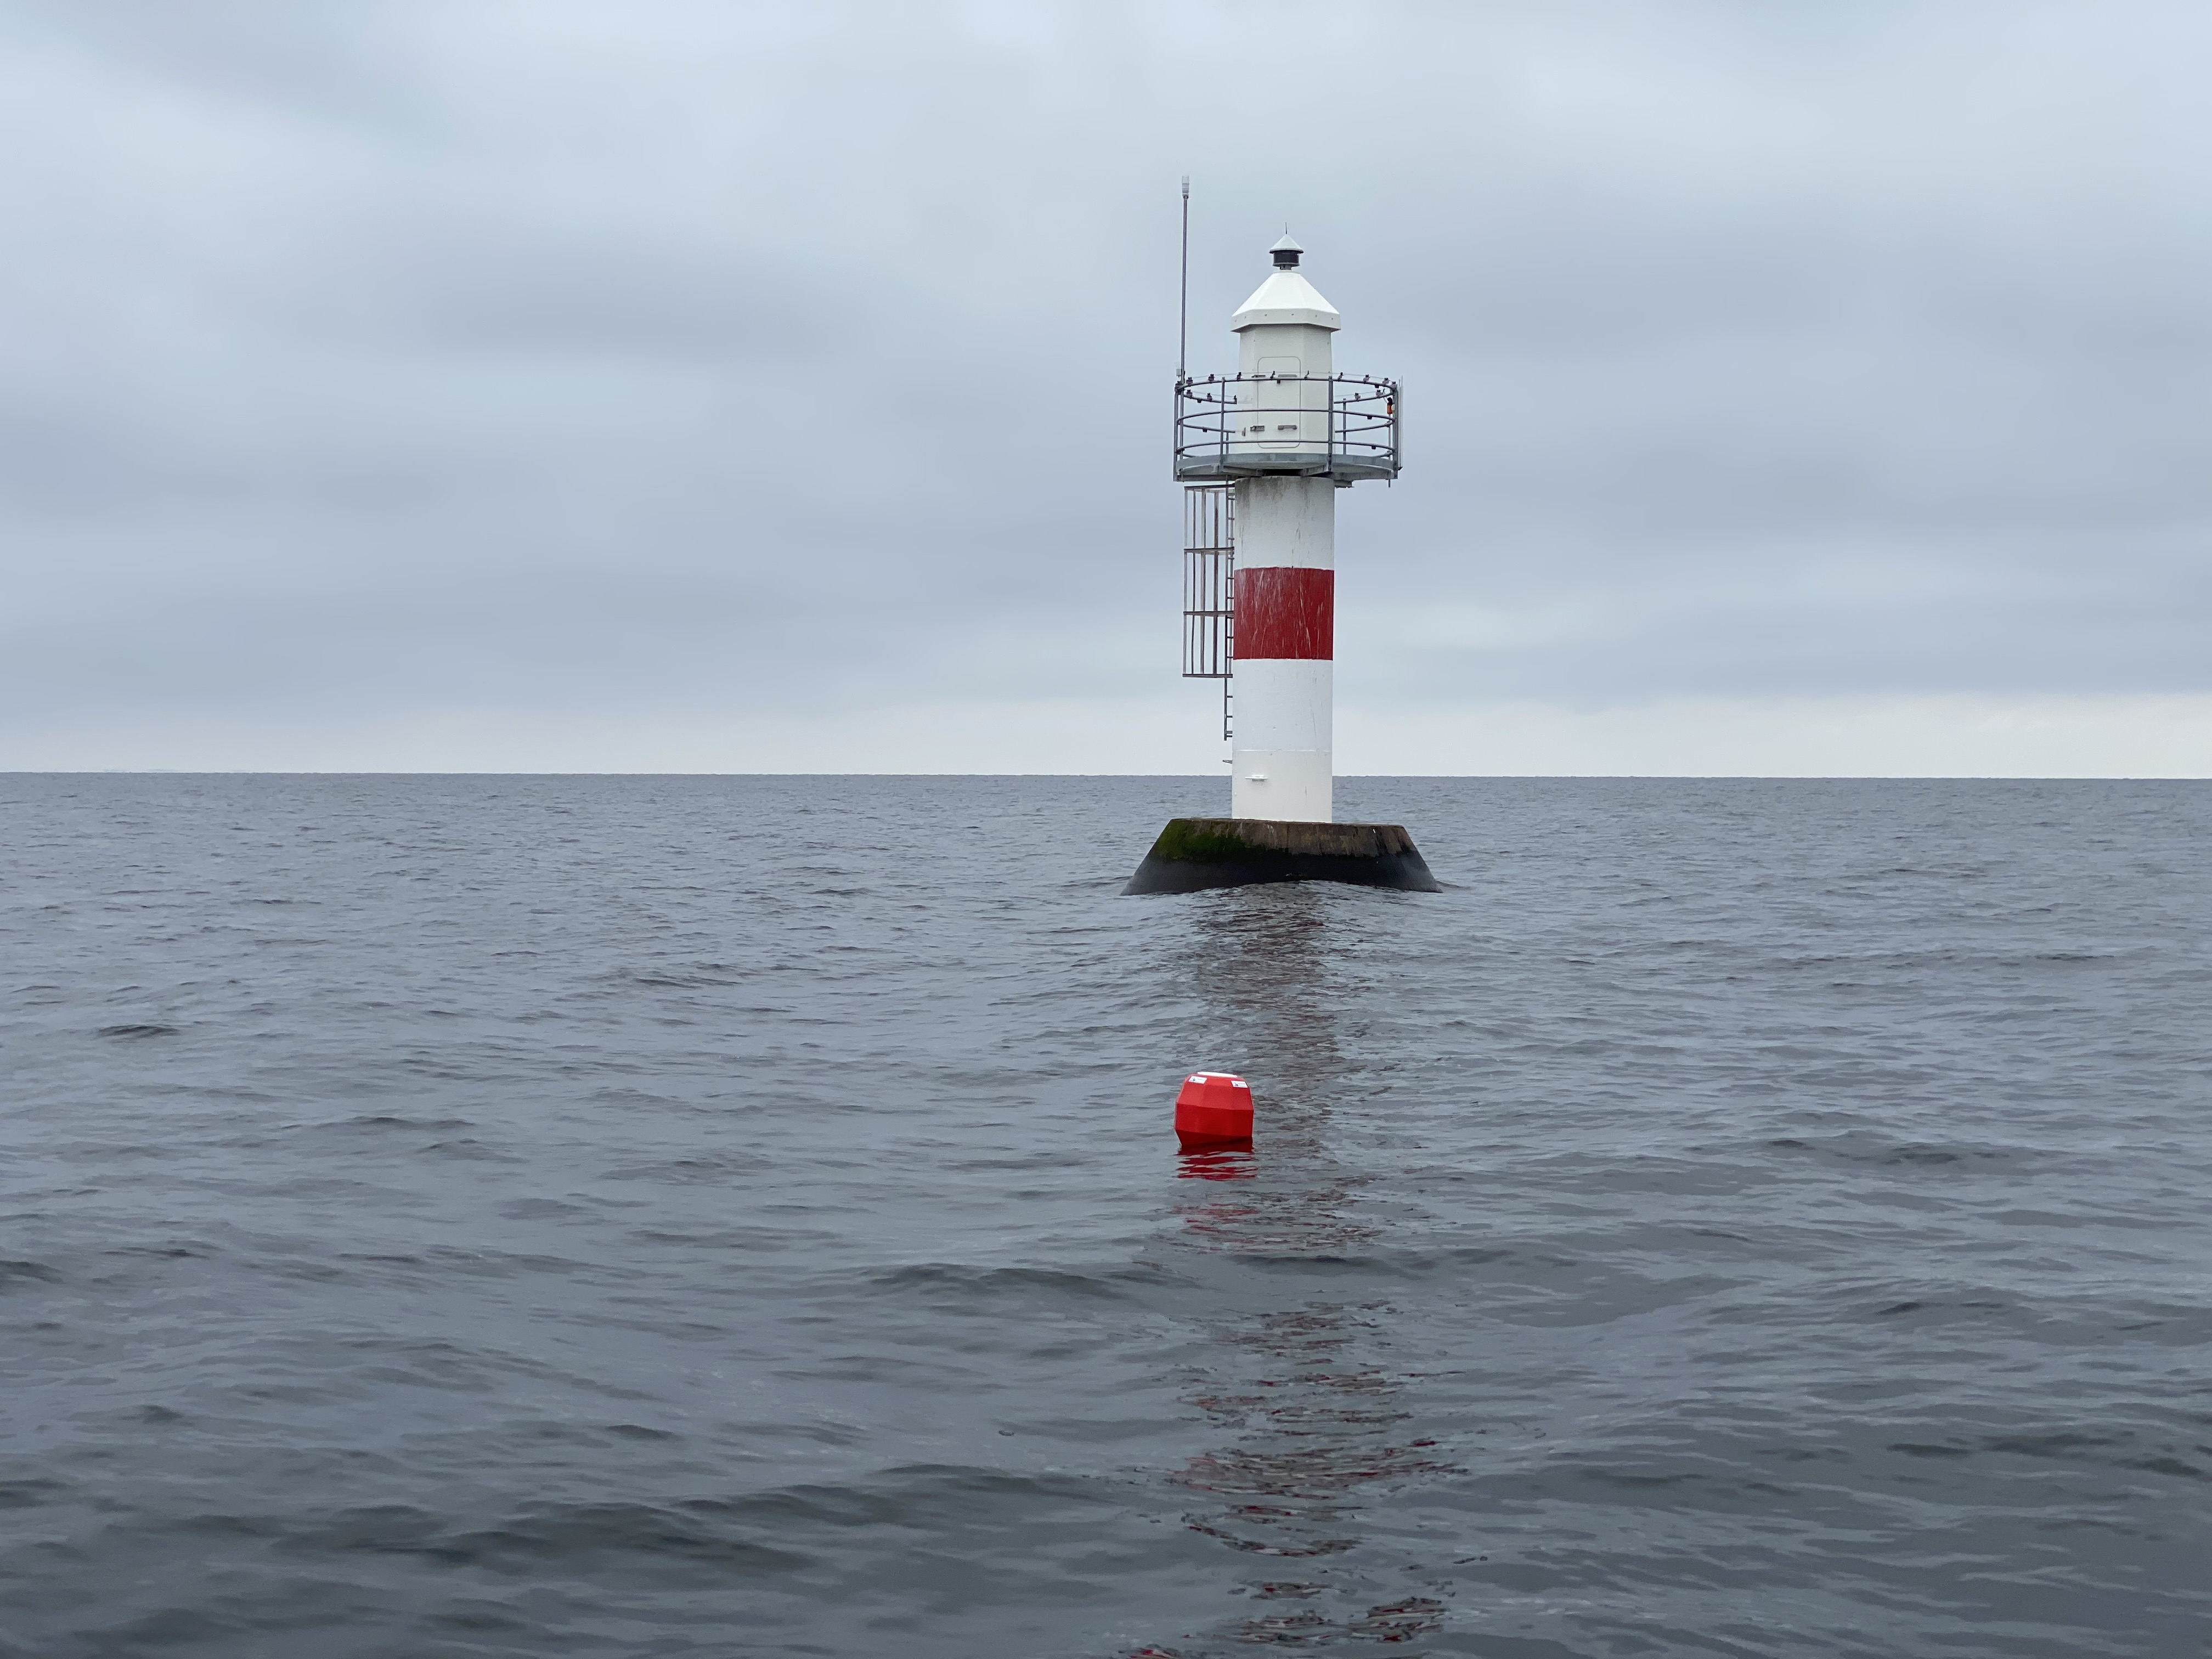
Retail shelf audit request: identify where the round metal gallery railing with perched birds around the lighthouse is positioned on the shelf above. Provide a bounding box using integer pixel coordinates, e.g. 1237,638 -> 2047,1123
1175,374 -> 1402,480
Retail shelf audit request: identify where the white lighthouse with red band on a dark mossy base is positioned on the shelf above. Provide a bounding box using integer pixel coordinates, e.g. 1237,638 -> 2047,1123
1124,234 -> 1438,894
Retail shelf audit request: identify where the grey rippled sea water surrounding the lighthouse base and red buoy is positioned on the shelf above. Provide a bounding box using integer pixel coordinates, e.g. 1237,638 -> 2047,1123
0,776 -> 2212,1659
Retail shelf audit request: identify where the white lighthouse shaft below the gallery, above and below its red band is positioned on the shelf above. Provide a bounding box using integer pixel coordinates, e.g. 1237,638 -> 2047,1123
1230,477 -> 1336,823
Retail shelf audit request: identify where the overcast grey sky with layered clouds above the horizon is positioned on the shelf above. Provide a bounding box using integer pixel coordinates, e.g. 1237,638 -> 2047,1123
0,0 -> 2212,774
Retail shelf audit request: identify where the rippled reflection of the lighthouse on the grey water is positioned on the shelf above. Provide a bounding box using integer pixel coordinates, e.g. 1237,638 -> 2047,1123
1175,889 -> 1447,1644
